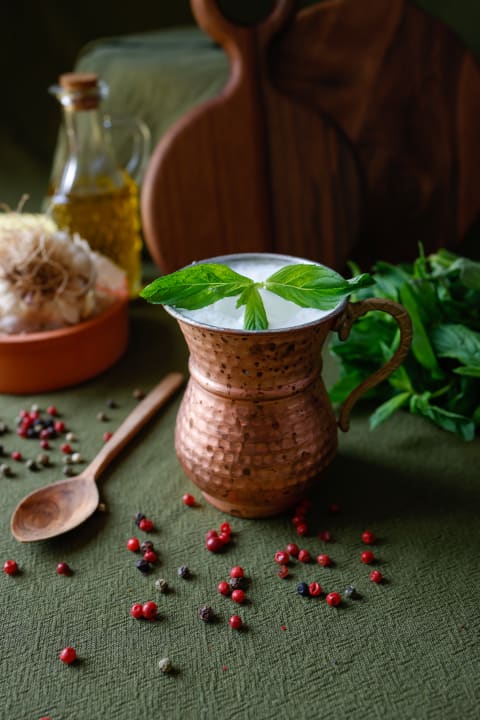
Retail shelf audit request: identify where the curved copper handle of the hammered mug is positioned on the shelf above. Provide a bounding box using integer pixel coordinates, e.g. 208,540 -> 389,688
333,298 -> 412,432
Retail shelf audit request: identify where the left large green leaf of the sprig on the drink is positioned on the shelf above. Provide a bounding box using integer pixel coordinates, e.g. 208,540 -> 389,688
140,263 -> 253,310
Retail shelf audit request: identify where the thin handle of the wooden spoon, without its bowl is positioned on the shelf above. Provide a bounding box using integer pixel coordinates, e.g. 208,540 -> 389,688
85,373 -> 184,480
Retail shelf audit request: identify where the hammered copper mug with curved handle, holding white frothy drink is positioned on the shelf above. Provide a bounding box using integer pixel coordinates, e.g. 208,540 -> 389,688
166,254 -> 412,518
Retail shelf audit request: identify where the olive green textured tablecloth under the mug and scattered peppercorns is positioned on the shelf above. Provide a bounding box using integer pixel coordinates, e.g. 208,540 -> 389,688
0,300 -> 480,720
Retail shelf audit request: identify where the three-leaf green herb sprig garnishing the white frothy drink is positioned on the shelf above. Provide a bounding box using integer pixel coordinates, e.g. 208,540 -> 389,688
140,263 -> 373,330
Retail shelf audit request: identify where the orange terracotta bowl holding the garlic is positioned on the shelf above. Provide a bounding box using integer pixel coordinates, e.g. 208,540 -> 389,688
0,296 -> 128,394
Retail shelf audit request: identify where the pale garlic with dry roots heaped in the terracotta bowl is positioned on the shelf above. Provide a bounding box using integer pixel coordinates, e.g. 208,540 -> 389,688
0,212 -> 126,334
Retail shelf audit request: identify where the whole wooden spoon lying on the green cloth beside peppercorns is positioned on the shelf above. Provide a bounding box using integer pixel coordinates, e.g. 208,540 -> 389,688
10,373 -> 184,542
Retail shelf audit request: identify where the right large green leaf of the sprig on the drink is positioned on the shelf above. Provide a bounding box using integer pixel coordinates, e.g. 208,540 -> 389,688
265,263 -> 373,310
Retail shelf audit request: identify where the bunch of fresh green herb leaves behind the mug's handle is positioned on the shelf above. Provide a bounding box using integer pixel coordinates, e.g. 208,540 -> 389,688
329,248 -> 480,440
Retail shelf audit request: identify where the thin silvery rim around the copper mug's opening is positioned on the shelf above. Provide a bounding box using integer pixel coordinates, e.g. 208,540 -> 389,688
163,252 -> 348,337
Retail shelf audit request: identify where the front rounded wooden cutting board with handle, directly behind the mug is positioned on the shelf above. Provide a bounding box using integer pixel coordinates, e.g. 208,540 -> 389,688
141,0 -> 361,272
